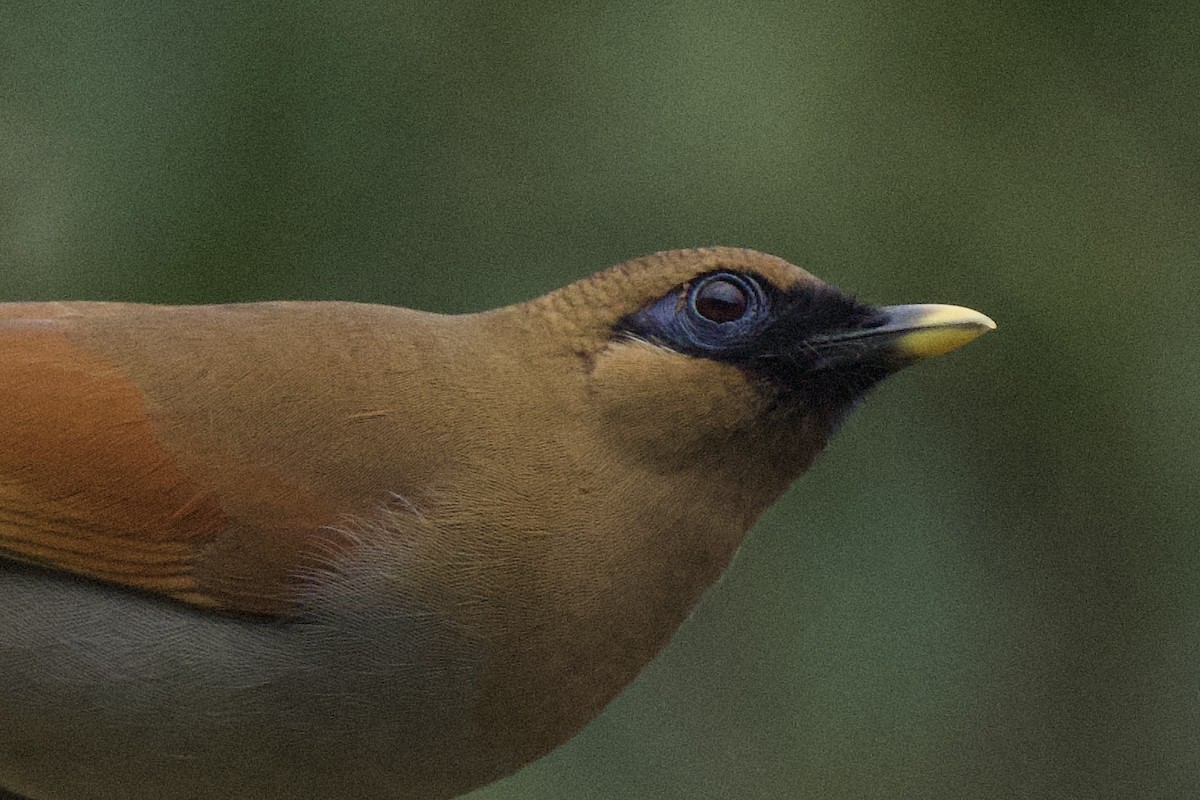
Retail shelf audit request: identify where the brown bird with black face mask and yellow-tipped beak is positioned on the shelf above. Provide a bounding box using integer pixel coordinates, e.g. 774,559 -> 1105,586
0,247 -> 995,800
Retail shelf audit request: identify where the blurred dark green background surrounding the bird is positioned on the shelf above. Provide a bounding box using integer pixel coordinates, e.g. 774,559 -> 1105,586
0,0 -> 1200,800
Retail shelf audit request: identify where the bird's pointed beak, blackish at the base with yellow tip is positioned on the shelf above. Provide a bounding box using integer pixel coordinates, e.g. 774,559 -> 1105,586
808,303 -> 996,368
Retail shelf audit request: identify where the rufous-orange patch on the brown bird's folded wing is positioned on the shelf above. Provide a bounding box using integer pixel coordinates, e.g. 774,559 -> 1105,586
0,320 -> 229,606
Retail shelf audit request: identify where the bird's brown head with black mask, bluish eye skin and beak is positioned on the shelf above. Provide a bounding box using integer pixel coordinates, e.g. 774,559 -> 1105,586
506,247 -> 995,501
